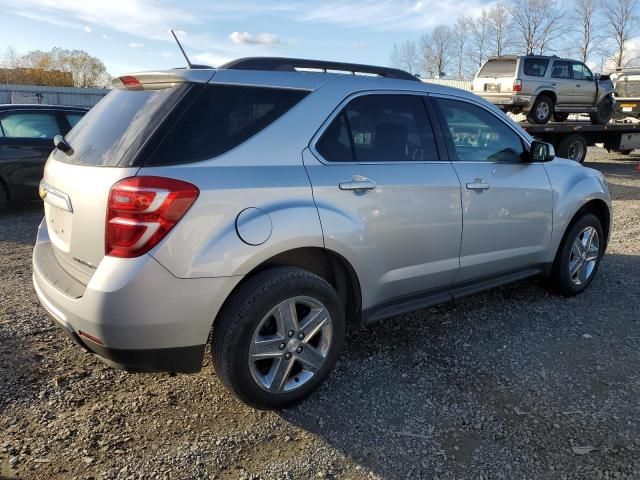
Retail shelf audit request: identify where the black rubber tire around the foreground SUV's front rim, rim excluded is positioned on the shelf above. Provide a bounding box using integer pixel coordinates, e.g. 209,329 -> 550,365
548,213 -> 606,297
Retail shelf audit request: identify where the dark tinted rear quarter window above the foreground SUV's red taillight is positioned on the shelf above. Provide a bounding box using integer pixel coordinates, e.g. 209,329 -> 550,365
150,85 -> 308,165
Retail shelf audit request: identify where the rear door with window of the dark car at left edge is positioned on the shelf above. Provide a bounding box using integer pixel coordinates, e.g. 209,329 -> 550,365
0,109 -> 63,199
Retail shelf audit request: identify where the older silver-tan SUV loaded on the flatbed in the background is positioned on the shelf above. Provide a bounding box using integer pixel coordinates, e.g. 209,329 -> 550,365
472,55 -> 614,124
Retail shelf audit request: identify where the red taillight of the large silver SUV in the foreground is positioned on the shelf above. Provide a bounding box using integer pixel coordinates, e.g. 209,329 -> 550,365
105,177 -> 200,258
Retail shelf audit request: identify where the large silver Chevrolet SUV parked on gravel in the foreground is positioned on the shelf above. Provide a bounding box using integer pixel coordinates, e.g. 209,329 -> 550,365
33,58 -> 611,408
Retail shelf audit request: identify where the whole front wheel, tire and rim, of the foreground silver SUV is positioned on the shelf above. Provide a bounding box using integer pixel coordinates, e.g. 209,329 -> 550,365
549,213 -> 605,297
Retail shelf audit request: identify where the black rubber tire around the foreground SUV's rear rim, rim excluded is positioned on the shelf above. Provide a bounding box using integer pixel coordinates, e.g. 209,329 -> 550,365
211,267 -> 345,409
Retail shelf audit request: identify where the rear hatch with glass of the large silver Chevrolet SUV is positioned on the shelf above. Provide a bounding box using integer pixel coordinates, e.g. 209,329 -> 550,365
41,73 -> 200,285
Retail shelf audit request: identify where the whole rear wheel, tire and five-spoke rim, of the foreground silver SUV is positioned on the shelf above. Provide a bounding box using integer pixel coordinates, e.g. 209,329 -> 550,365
212,267 -> 345,408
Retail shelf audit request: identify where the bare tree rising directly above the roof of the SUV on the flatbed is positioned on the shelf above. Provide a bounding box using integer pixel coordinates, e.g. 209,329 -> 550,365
510,0 -> 564,55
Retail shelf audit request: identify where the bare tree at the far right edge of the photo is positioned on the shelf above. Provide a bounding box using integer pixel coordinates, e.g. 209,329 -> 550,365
602,0 -> 637,67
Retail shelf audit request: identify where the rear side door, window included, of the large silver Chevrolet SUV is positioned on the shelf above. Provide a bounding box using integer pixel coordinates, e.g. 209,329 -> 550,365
303,92 -> 462,308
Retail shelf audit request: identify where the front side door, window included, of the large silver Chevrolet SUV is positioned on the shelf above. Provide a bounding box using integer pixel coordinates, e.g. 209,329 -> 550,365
436,98 -> 553,283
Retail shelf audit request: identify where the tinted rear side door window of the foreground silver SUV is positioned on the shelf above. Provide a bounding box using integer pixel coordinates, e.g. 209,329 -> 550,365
317,95 -> 438,162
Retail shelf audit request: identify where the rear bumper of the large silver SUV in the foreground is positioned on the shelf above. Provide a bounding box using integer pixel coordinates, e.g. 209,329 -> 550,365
33,216 -> 240,373
